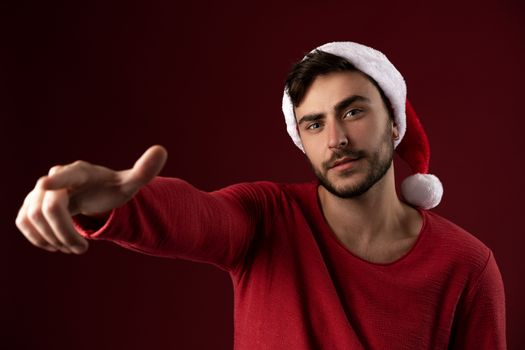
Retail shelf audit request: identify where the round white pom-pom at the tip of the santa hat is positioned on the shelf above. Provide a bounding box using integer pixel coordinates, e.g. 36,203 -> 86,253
401,174 -> 443,209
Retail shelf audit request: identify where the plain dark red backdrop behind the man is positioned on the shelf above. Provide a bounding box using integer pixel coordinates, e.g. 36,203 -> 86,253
0,0 -> 525,349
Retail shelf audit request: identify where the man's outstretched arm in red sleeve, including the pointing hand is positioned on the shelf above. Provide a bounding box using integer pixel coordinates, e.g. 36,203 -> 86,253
17,146 -> 270,270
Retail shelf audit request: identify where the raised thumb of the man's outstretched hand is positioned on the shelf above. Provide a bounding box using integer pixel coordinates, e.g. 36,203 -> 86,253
125,145 -> 168,191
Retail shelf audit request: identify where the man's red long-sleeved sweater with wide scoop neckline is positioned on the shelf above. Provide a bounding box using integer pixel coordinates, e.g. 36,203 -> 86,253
76,177 -> 506,350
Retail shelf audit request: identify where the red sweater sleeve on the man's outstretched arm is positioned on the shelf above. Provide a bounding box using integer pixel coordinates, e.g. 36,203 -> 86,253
74,177 -> 277,271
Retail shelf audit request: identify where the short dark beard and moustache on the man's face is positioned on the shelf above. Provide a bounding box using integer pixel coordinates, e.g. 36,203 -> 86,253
310,127 -> 394,198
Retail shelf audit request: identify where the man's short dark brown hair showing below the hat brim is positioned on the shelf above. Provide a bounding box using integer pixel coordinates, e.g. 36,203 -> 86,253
285,50 -> 394,120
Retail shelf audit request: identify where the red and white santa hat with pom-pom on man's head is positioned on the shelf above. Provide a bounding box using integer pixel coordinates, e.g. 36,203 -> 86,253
282,41 -> 443,209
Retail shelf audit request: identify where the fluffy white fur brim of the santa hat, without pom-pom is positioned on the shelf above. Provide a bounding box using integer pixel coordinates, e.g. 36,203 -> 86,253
282,41 -> 407,152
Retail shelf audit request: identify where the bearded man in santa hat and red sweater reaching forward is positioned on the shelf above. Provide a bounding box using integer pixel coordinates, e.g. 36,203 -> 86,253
17,42 -> 506,349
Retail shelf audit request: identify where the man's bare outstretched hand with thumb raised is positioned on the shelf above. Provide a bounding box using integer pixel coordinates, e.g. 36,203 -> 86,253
16,146 -> 167,254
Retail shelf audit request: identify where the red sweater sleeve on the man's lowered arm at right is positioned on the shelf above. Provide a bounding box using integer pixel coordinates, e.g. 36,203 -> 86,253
450,251 -> 507,350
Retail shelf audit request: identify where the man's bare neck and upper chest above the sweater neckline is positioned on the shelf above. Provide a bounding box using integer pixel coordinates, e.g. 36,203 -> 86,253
318,167 -> 422,246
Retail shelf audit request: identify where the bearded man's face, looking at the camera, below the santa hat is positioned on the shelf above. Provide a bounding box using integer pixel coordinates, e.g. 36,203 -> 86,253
295,72 -> 397,198
